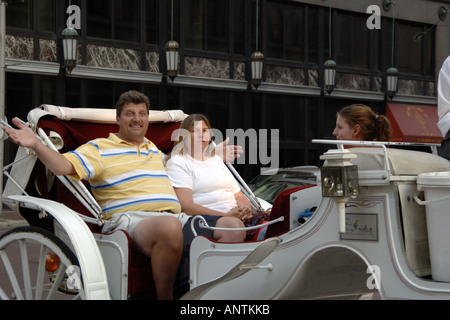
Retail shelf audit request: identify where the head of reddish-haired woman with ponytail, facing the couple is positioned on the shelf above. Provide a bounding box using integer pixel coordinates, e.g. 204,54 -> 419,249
333,104 -> 392,141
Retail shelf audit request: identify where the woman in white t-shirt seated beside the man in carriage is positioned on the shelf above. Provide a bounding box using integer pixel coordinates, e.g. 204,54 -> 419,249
166,114 -> 252,242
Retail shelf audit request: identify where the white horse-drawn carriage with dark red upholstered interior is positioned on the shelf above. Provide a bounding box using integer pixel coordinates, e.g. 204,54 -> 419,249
0,109 -> 450,300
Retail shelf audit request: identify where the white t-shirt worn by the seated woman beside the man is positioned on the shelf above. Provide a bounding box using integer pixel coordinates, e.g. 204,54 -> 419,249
166,155 -> 240,212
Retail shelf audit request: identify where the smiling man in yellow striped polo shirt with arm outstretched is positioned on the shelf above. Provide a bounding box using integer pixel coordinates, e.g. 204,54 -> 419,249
3,91 -> 241,299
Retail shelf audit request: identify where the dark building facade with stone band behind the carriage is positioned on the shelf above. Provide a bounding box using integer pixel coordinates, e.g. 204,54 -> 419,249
4,0 -> 450,180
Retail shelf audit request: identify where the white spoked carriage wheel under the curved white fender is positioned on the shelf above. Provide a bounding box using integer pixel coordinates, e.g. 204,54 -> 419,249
0,227 -> 84,300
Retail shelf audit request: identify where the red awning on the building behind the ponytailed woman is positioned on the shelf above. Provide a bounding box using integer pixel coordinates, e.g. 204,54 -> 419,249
386,103 -> 442,143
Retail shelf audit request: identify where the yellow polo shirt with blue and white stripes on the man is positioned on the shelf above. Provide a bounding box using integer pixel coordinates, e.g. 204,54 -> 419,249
64,133 -> 181,219
